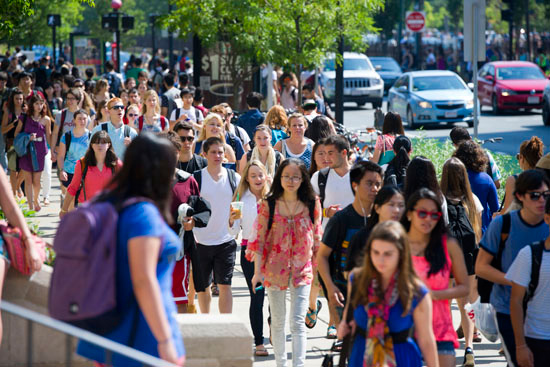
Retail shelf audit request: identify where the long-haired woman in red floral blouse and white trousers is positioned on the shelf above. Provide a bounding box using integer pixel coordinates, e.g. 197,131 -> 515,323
247,158 -> 321,367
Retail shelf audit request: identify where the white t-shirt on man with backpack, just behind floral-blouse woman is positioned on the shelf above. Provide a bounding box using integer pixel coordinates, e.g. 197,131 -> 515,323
311,169 -> 355,230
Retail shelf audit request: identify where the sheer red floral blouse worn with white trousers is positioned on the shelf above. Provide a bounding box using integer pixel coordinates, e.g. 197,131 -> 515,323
246,199 -> 322,290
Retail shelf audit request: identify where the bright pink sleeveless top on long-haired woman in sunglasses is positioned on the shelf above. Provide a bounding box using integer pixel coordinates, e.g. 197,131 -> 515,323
412,236 -> 459,348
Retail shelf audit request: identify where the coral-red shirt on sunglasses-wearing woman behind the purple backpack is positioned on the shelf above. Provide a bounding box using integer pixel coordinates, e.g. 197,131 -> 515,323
67,159 -> 122,203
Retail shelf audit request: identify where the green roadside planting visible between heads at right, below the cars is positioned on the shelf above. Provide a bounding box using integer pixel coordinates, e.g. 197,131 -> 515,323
411,133 -> 521,201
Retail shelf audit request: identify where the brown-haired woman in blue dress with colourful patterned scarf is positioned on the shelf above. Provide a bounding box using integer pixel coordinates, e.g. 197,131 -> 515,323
338,221 -> 438,367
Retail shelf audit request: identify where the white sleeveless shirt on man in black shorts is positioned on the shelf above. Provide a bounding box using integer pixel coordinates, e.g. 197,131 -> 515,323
193,168 -> 241,246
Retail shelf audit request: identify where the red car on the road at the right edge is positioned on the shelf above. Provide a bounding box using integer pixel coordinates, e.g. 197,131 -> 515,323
477,61 -> 548,114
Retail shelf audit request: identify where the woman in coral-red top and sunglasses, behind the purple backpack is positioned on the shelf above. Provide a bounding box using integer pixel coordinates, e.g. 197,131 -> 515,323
59,130 -> 122,217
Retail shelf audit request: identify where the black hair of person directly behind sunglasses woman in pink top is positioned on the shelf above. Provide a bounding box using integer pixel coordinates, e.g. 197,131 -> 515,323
403,155 -> 449,225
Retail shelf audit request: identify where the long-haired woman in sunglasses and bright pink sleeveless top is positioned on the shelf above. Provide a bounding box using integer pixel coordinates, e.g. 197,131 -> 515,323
401,190 -> 473,367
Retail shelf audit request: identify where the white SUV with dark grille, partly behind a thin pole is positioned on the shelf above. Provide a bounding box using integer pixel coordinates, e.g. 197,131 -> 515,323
321,52 -> 384,108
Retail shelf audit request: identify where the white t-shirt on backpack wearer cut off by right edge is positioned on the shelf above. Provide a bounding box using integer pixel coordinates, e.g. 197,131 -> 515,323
506,246 -> 550,340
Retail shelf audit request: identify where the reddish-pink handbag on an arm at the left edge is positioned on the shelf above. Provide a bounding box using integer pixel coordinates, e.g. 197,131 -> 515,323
0,220 -> 46,275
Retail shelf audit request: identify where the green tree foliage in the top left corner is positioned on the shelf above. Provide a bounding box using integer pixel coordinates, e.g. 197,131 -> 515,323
0,0 -> 95,45
